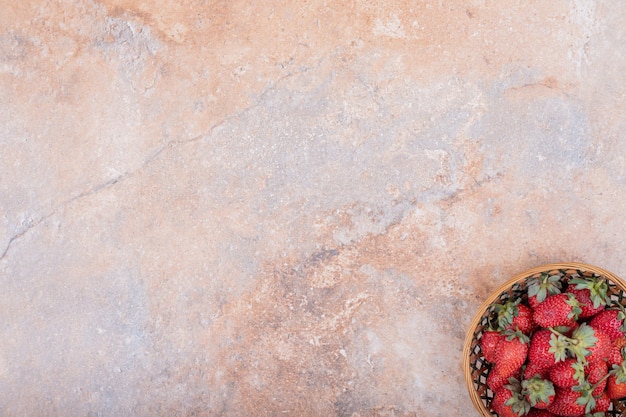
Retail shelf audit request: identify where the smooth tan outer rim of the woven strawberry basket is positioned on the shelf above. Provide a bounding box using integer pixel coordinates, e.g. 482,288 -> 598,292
463,262 -> 626,417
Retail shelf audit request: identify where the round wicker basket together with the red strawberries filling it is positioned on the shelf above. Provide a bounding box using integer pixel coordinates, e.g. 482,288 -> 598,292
463,263 -> 626,417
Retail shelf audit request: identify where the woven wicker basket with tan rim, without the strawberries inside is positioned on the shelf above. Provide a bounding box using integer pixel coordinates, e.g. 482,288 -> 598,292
463,263 -> 626,417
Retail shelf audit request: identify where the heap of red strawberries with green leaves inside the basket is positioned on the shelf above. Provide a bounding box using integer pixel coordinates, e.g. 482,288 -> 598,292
480,272 -> 626,417
